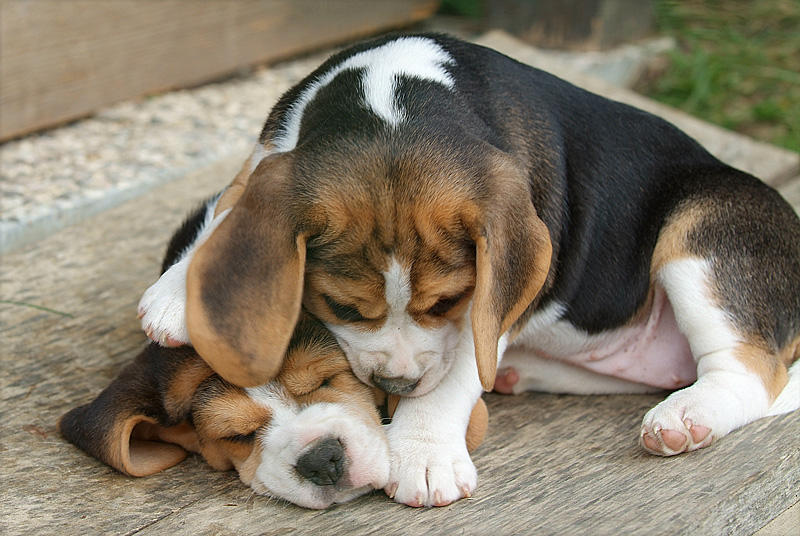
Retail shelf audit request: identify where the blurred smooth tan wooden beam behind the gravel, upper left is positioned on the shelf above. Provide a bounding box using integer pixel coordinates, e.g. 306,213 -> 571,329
0,0 -> 438,140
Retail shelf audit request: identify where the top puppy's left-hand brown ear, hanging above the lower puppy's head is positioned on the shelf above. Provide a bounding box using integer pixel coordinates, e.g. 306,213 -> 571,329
186,153 -> 306,387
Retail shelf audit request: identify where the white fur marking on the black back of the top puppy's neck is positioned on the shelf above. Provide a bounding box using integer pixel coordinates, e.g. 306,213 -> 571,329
274,37 -> 455,152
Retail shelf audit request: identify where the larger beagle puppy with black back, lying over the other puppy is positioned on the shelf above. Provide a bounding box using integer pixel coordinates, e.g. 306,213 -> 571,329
140,34 -> 800,506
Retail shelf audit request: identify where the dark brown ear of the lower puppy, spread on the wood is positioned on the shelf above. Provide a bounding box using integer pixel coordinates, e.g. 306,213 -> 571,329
58,343 -> 213,476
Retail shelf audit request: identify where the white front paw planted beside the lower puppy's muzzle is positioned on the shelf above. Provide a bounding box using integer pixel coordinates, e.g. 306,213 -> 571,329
385,434 -> 478,507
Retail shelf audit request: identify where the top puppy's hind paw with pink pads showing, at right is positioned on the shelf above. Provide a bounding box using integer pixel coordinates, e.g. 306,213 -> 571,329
639,390 -> 716,456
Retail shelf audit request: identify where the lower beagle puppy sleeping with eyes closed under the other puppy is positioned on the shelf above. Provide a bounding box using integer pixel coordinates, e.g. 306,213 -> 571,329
59,201 -> 487,508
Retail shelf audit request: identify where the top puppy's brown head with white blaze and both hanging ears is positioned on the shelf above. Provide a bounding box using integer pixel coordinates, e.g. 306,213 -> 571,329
187,133 -> 551,395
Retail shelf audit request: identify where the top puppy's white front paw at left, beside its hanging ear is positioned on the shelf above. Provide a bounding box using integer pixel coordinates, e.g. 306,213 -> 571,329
139,256 -> 191,346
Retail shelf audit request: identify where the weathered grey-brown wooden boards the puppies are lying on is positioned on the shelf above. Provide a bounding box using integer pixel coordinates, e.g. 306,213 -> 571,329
0,158 -> 800,535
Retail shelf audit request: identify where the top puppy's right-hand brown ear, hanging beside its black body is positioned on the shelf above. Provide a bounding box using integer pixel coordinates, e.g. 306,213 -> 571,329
466,151 -> 552,391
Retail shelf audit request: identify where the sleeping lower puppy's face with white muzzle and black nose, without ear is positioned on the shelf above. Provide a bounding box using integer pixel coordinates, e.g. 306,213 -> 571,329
192,316 -> 389,508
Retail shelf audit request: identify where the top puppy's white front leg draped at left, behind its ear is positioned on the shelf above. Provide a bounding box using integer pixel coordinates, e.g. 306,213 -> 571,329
138,198 -> 230,346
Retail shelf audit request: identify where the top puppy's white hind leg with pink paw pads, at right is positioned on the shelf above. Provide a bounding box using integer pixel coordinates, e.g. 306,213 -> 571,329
639,257 -> 800,456
